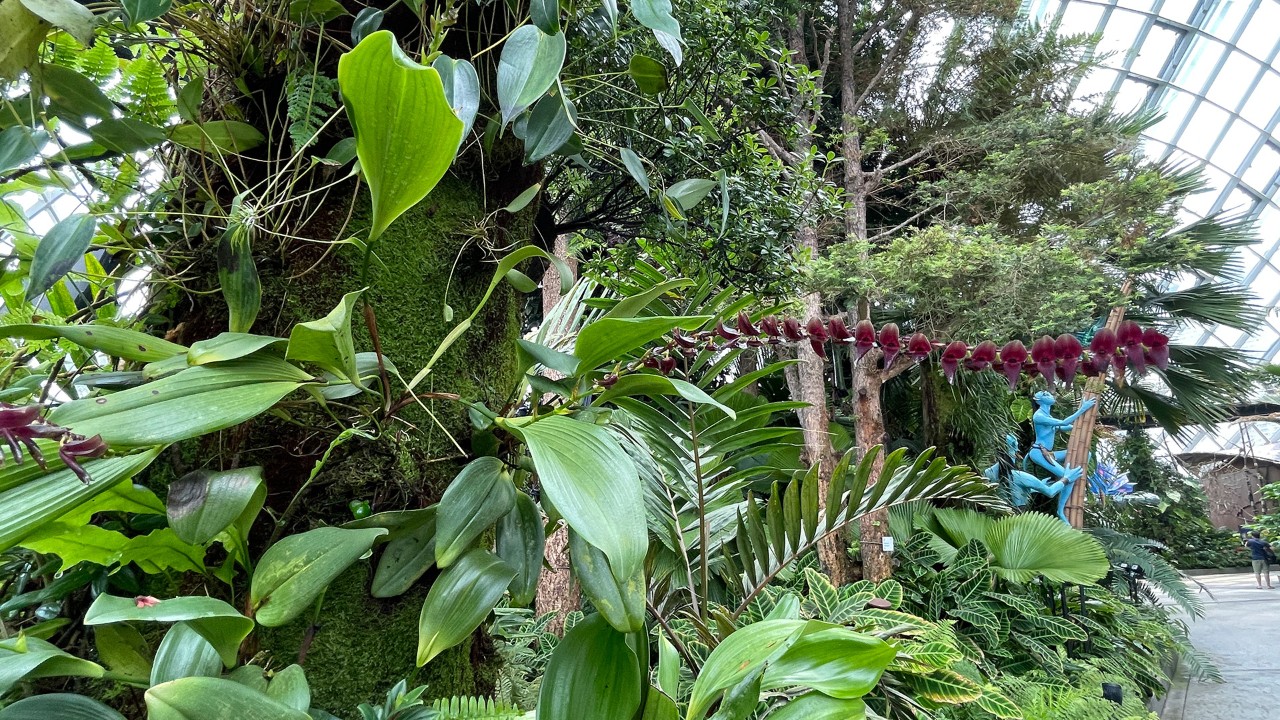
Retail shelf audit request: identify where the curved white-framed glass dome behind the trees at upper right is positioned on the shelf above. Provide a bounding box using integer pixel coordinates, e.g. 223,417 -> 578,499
1024,0 -> 1280,451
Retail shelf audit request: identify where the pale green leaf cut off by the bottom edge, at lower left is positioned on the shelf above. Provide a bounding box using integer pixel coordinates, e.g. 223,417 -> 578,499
146,678 -> 311,720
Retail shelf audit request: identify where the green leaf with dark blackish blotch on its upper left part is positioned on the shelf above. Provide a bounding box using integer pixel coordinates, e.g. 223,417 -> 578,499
165,466 -> 264,544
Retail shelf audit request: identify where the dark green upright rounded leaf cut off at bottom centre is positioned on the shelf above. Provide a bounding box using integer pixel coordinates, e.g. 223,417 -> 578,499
536,615 -> 648,720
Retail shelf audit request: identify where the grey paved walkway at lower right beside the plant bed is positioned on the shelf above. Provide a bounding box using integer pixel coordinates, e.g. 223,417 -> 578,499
1160,570 -> 1280,720
